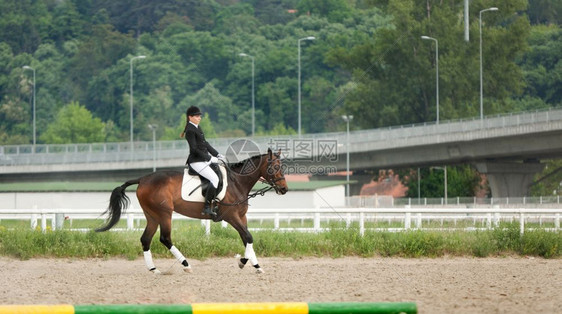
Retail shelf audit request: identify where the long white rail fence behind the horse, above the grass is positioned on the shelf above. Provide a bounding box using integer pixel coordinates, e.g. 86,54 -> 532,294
0,207 -> 562,235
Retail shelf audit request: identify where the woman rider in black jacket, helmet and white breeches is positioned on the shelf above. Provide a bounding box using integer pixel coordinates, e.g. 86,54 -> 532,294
181,106 -> 224,216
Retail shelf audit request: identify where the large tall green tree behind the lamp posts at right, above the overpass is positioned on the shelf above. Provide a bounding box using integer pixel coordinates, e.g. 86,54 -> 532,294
331,0 -> 529,128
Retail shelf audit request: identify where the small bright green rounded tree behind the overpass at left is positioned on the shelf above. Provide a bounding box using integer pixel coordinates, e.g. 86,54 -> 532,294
40,102 -> 105,144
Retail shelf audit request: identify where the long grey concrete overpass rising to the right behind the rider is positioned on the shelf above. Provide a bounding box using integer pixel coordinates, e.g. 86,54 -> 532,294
0,109 -> 562,197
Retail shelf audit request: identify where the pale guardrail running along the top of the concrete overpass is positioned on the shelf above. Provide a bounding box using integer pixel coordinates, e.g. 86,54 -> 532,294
0,109 -> 562,167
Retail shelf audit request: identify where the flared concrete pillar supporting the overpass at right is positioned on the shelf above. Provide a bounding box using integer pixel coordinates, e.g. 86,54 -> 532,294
476,160 -> 545,197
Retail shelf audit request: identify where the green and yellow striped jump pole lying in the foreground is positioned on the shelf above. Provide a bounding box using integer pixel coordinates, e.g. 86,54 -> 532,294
0,302 -> 412,314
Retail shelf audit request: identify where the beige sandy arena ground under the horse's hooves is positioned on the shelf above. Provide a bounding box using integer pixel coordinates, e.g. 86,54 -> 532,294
0,257 -> 562,313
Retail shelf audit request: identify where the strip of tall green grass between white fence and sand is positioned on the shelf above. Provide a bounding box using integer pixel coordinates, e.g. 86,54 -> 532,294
0,221 -> 562,259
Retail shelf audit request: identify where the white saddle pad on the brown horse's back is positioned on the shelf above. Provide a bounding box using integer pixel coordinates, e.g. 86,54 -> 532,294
181,164 -> 228,203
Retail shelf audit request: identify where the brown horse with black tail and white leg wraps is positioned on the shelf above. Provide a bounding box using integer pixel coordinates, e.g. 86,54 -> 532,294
96,149 -> 289,274
